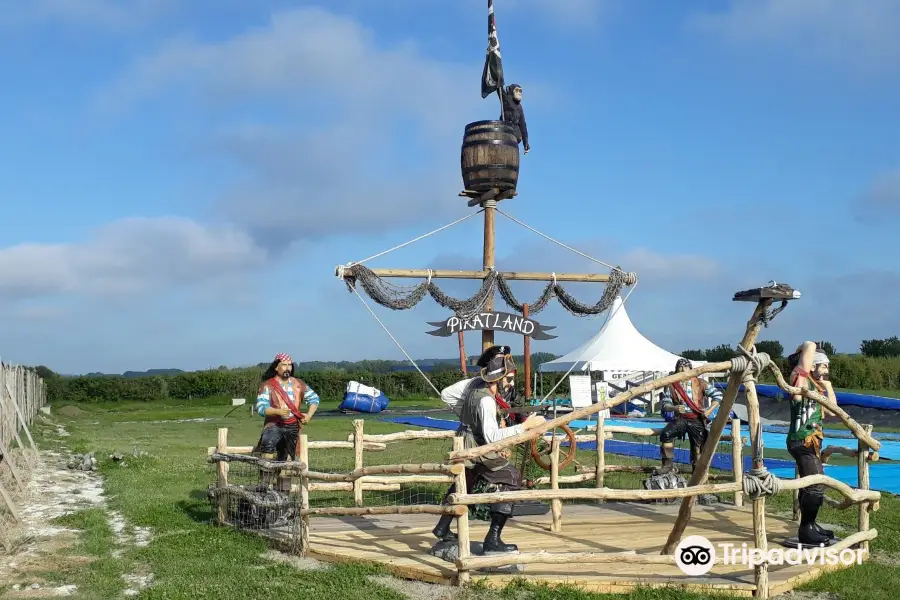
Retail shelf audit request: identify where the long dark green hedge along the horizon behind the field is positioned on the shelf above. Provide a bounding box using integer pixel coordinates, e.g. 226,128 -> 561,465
45,355 -> 900,402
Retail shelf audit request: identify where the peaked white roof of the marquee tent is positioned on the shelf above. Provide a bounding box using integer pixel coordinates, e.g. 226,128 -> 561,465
538,297 -> 706,381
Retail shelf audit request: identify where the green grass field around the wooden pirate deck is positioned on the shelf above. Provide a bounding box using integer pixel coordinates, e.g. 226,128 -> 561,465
7,400 -> 900,600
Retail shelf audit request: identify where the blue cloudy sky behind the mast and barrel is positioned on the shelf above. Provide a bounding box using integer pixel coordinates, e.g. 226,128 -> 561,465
0,0 -> 900,374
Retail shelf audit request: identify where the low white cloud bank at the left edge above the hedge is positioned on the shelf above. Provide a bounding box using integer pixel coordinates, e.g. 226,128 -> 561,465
0,217 -> 266,300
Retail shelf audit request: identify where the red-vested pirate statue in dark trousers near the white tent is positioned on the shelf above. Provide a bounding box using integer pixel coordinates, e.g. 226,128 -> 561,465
657,358 -> 722,475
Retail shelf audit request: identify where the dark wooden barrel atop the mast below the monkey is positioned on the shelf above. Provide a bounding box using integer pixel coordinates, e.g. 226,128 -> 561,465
460,121 -> 519,192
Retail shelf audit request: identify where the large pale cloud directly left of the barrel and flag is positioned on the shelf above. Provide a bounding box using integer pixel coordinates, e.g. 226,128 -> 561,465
98,7 -> 520,249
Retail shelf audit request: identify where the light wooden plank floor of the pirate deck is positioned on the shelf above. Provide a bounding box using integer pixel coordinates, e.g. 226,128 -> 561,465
258,503 -> 856,596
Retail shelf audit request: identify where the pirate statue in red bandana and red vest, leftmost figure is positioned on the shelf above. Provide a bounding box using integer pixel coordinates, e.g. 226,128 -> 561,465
254,354 -> 319,472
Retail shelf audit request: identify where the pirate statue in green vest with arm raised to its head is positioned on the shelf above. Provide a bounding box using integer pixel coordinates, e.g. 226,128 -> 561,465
787,342 -> 837,546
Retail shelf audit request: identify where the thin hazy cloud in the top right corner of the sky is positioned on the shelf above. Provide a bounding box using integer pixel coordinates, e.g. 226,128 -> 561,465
689,0 -> 900,72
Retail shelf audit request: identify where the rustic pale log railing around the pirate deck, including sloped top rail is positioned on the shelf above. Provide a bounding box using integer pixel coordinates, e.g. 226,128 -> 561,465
209,364 -> 881,598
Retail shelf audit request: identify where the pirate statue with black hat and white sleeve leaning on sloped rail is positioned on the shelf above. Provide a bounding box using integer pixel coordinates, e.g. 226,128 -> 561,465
433,346 -> 545,553
